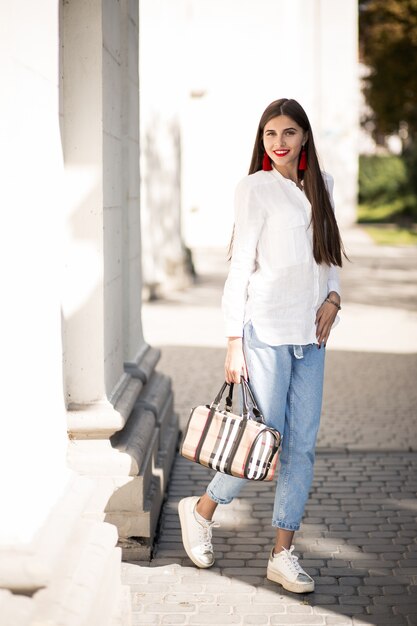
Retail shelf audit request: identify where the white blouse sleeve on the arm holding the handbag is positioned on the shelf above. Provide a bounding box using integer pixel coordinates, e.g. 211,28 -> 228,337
222,178 -> 264,337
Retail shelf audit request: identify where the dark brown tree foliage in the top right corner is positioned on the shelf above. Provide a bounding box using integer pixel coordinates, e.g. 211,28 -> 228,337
359,0 -> 417,145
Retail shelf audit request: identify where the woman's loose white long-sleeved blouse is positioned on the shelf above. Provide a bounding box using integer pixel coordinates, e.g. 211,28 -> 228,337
222,169 -> 340,346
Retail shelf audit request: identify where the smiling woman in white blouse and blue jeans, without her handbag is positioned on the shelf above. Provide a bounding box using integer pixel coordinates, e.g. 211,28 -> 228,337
179,98 -> 344,593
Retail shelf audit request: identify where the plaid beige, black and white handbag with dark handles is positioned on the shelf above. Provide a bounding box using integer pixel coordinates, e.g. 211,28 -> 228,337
180,377 -> 281,480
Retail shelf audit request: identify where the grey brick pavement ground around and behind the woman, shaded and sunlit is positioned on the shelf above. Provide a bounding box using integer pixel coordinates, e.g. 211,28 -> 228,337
123,232 -> 417,626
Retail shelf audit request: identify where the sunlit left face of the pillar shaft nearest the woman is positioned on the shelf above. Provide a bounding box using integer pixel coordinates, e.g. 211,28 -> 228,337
62,0 -> 106,406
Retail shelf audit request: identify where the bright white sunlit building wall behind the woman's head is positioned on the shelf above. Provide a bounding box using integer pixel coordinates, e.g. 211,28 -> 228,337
141,0 -> 358,247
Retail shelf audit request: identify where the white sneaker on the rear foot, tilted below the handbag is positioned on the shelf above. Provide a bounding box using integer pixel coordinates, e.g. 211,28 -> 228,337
178,496 -> 219,567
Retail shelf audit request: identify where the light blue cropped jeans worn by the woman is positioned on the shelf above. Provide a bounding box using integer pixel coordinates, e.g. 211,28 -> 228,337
207,322 -> 325,530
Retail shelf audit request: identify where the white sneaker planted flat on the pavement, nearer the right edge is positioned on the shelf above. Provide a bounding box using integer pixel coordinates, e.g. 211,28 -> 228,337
266,546 -> 314,593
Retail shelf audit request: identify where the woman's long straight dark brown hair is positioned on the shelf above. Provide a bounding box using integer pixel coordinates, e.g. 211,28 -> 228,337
230,98 -> 347,267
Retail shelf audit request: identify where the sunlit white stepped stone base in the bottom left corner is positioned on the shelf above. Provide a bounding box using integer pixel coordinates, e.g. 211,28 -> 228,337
0,476 -> 131,626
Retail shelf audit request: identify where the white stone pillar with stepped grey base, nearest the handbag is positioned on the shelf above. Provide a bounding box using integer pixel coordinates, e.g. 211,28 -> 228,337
62,0 -> 178,551
